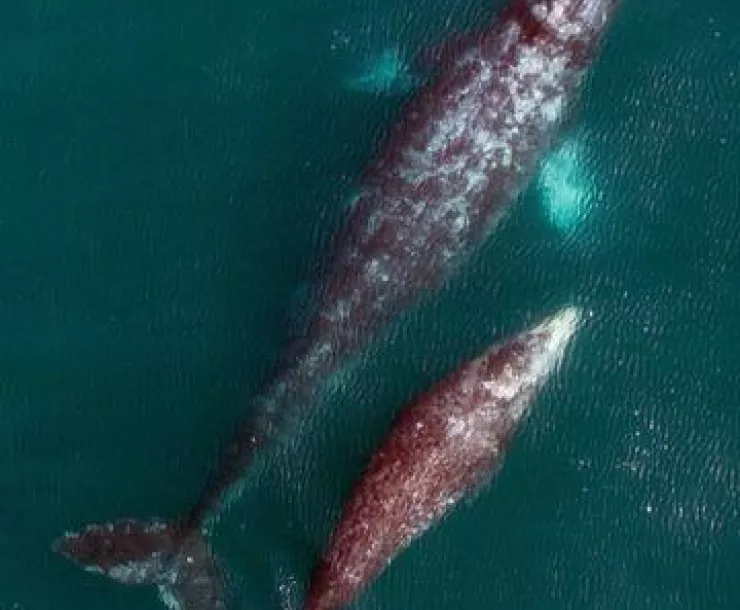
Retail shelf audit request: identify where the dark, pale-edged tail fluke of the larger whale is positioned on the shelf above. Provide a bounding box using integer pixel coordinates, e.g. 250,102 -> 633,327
53,520 -> 226,610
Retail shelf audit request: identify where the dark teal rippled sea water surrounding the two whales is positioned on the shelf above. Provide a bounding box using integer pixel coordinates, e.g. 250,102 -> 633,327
0,0 -> 740,610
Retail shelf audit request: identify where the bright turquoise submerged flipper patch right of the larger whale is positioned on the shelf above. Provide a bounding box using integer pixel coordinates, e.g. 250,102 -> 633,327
537,140 -> 595,232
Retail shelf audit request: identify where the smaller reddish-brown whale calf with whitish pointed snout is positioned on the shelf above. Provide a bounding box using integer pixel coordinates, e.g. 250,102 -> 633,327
305,307 -> 580,610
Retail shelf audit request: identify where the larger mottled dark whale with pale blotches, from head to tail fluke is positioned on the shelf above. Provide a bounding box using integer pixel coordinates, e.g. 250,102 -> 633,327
54,0 -> 617,610
